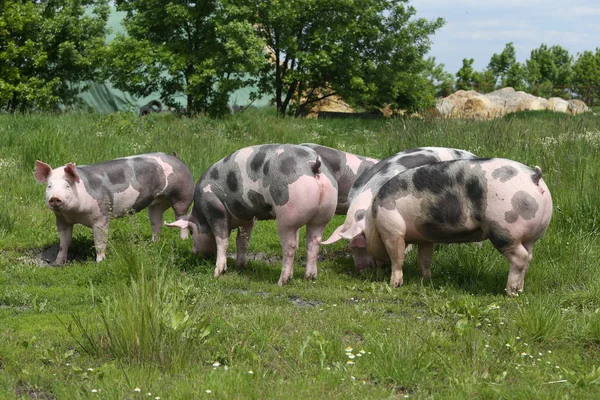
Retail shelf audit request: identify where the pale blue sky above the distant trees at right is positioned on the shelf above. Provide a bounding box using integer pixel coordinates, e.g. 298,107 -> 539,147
411,0 -> 600,74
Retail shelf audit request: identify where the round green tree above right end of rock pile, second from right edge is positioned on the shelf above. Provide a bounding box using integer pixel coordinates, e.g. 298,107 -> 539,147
526,44 -> 573,97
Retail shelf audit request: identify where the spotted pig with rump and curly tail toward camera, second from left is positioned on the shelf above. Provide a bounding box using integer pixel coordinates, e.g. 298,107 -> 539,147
167,144 -> 338,286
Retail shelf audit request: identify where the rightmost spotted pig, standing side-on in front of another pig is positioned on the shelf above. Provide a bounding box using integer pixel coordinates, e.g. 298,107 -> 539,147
364,158 -> 552,296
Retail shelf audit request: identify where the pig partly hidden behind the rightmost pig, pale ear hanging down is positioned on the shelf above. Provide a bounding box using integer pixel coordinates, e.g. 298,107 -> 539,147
323,147 -> 477,272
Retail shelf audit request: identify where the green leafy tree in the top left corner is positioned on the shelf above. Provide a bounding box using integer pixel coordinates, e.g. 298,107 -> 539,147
0,0 -> 108,112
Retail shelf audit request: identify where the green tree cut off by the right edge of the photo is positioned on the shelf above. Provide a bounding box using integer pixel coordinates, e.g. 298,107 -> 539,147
573,49 -> 600,105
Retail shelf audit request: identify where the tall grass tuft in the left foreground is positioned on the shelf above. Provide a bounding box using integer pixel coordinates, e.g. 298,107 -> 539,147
69,268 -> 210,373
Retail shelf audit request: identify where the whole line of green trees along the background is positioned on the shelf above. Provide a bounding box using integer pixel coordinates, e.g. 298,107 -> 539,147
0,0 -> 600,116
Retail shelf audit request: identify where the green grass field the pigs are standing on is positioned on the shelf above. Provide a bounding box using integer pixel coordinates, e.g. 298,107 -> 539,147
0,111 -> 600,399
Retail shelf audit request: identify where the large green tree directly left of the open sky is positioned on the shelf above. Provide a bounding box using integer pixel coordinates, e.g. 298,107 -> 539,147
245,0 -> 444,115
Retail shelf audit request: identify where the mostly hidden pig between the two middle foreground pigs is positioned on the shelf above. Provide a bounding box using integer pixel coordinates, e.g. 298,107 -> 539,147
301,143 -> 379,215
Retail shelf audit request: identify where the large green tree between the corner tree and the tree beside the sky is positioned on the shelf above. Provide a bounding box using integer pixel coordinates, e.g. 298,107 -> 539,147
106,0 -> 266,116
